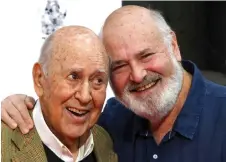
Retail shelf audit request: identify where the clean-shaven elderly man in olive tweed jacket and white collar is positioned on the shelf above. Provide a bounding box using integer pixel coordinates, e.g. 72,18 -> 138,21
1,26 -> 117,162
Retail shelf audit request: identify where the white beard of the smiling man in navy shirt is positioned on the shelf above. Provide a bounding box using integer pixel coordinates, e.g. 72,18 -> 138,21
118,55 -> 183,122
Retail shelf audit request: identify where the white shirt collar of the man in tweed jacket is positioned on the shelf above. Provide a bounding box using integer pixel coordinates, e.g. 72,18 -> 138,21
32,100 -> 94,162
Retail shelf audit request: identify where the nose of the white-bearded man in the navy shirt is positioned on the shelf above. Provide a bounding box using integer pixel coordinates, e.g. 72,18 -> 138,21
130,66 -> 147,83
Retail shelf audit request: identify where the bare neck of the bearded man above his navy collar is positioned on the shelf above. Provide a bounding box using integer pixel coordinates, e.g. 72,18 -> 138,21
150,71 -> 192,144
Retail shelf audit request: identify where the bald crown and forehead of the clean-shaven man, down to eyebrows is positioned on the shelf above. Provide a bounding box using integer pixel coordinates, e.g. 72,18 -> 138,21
45,26 -> 108,70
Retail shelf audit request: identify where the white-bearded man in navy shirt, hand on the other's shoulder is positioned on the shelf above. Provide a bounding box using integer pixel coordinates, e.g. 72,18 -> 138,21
2,6 -> 226,162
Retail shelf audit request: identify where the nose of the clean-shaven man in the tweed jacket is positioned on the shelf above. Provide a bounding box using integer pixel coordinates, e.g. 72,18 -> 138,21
74,81 -> 92,105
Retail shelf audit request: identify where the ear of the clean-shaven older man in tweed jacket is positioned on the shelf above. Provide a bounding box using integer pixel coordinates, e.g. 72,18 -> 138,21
32,63 -> 45,97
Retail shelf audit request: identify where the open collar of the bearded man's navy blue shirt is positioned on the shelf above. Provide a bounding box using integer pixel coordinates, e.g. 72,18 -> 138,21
133,61 -> 206,139
